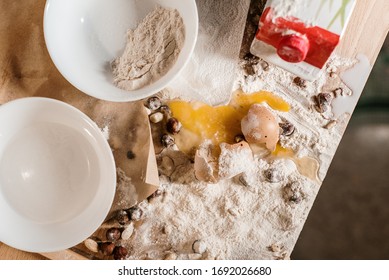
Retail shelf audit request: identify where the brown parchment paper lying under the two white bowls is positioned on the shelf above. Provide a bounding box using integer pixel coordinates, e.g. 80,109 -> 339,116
0,0 -> 159,214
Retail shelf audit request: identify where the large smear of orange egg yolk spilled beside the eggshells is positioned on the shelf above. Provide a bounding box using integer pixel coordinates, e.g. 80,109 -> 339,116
169,91 -> 290,152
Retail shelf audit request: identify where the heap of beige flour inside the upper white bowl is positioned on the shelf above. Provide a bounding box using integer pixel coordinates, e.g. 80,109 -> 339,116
111,7 -> 185,91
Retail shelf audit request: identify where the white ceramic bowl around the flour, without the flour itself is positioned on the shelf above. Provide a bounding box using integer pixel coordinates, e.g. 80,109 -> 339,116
44,0 -> 198,102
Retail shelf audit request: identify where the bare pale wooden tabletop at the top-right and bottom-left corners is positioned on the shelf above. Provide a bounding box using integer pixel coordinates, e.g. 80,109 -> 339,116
0,0 -> 389,260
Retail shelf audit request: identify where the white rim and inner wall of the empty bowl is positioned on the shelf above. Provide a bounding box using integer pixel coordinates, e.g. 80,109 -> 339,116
0,97 -> 116,253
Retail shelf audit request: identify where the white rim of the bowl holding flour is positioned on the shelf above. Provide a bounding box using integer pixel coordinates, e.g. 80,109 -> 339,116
43,0 -> 199,102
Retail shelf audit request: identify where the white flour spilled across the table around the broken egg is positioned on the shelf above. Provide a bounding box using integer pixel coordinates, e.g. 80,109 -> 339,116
86,51 -> 352,259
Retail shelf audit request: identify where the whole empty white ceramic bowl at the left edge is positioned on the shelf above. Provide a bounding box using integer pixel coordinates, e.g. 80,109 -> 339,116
0,97 -> 116,252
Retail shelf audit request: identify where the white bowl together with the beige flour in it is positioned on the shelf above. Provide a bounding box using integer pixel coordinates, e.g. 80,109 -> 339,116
44,0 -> 198,102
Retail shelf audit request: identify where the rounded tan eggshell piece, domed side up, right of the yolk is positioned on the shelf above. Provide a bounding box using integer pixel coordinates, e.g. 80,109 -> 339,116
241,104 -> 280,151
